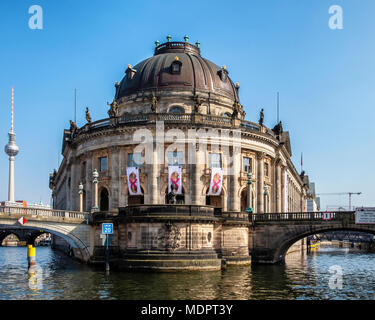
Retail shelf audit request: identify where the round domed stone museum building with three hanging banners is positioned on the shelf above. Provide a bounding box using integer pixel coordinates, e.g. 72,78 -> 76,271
50,37 -> 309,270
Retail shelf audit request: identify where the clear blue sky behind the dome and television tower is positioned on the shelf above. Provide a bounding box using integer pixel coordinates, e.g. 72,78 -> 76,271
0,0 -> 375,209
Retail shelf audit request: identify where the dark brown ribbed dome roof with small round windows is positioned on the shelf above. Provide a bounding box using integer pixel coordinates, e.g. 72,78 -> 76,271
116,42 -> 239,101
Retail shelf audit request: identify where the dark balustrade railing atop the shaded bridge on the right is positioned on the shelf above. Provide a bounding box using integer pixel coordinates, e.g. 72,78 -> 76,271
253,211 -> 355,223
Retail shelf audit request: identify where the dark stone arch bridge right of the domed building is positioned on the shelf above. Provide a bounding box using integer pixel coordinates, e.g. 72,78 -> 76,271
250,211 -> 375,264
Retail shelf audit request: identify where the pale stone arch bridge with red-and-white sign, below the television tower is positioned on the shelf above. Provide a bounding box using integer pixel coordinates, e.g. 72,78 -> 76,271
0,206 -> 94,262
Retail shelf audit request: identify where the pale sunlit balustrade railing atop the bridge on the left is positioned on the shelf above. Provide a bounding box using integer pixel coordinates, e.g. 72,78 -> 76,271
0,205 -> 89,220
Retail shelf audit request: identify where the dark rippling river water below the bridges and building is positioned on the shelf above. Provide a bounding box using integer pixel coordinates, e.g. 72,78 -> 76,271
0,247 -> 375,300
